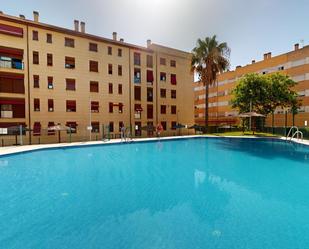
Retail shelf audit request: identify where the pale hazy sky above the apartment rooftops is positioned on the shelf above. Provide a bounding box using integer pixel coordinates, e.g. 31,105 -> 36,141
0,0 -> 309,69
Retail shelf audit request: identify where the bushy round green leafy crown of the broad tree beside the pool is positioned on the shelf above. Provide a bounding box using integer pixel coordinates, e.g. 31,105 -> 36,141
232,73 -> 300,127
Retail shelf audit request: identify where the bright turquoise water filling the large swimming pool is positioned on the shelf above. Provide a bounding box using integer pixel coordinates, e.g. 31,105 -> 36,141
0,138 -> 309,249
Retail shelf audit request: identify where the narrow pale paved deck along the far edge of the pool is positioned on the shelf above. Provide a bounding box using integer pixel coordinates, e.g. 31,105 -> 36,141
0,135 -> 309,156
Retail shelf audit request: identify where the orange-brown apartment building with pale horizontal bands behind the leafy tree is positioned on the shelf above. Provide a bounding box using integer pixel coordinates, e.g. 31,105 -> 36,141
194,44 -> 309,127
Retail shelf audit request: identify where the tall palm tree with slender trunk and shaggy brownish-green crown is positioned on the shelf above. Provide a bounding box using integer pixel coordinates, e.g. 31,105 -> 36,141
191,35 -> 230,131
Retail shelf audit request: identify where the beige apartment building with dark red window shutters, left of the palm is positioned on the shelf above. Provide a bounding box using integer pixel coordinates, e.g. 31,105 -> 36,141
0,11 -> 194,142
